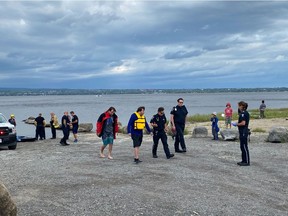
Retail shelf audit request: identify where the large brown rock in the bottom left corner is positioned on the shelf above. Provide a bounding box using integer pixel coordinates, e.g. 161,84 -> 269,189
0,181 -> 17,216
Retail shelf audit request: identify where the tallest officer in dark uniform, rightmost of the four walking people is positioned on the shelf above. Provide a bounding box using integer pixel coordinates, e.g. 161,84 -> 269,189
170,98 -> 188,153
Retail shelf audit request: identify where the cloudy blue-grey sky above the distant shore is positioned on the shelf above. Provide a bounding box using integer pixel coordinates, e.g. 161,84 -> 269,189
0,0 -> 288,89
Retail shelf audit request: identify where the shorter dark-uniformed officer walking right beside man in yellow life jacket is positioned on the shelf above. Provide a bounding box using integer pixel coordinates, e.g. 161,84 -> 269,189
150,107 -> 174,159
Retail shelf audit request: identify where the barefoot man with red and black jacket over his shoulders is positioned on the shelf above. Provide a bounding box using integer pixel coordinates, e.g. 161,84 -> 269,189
96,107 -> 119,160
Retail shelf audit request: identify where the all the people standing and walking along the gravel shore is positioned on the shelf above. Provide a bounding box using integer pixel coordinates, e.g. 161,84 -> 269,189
9,98 -> 266,166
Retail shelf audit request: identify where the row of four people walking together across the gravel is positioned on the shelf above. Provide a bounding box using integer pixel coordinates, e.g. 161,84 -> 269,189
96,98 -> 188,164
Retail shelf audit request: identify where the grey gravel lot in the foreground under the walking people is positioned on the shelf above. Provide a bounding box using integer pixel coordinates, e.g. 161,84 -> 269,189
0,133 -> 288,216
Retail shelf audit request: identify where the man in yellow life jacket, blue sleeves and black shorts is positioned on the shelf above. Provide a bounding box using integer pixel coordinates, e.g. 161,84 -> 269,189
127,106 -> 152,164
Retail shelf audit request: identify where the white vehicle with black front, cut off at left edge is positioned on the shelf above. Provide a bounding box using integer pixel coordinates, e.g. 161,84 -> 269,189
0,113 -> 17,150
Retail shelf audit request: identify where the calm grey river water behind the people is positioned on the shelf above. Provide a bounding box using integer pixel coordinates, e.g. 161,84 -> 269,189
0,92 -> 288,137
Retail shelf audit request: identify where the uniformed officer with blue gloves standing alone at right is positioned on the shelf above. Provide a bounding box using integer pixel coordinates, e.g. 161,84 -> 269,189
232,101 -> 250,166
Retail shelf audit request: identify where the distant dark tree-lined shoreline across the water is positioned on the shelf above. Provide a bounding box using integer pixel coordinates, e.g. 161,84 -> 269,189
0,87 -> 288,96
